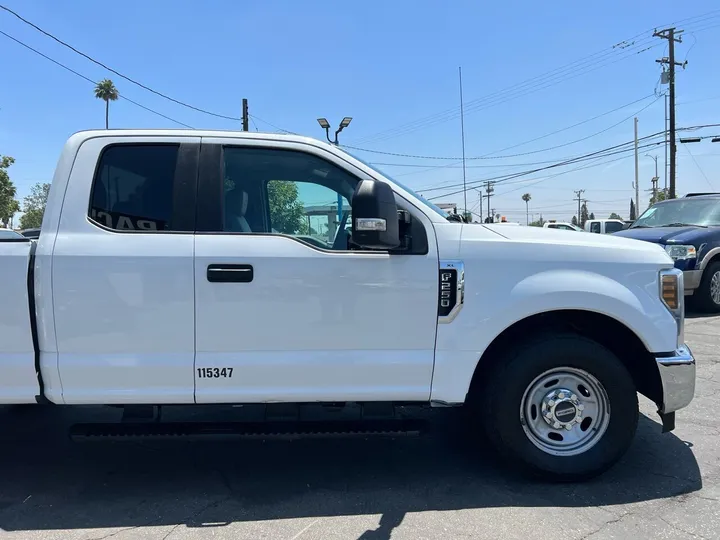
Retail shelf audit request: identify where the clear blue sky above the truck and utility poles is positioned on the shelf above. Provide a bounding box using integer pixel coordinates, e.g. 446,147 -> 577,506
0,0 -> 720,223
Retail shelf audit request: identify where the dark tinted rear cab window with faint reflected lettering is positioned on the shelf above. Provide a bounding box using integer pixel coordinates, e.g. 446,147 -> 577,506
89,144 -> 179,231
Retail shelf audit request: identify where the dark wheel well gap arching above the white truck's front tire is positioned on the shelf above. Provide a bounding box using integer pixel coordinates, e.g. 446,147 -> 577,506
471,310 -> 663,403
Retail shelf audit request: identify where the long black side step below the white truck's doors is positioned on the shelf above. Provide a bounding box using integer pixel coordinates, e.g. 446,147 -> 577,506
70,419 -> 426,442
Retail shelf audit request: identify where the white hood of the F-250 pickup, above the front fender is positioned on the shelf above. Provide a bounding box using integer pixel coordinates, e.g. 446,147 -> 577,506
472,224 -> 672,265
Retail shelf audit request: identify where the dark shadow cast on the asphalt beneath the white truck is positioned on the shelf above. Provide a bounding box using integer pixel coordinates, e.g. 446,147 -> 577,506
0,407 -> 702,540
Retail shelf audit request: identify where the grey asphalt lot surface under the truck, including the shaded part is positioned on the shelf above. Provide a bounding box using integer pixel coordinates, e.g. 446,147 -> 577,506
0,316 -> 720,540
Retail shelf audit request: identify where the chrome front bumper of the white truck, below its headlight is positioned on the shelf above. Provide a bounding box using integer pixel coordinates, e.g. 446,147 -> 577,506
655,345 -> 695,415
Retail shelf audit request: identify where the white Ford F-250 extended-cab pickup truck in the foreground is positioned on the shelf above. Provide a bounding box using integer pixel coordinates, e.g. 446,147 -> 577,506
0,130 -> 695,480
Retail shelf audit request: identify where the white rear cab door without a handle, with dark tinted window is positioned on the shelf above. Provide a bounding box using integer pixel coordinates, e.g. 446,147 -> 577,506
51,136 -> 200,404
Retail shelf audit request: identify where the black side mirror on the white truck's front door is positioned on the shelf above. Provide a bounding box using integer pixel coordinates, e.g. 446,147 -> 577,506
350,180 -> 400,249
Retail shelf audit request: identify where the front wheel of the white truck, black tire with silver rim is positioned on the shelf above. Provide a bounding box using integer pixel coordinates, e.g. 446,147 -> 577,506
474,334 -> 639,482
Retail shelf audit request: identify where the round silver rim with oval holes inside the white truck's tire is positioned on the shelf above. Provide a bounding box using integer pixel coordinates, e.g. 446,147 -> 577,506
520,368 -> 612,456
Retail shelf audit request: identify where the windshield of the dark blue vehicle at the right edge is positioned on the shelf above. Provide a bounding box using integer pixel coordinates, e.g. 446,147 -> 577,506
630,198 -> 720,229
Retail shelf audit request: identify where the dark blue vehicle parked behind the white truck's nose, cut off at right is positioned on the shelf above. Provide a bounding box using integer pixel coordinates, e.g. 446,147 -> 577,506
615,193 -> 720,312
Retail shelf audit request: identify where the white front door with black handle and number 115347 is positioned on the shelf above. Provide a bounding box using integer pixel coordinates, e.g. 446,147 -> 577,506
195,139 -> 438,403
